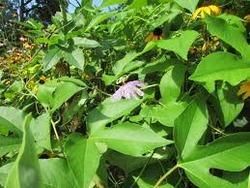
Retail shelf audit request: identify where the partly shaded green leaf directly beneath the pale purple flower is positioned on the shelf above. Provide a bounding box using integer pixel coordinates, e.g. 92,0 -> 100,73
87,98 -> 142,134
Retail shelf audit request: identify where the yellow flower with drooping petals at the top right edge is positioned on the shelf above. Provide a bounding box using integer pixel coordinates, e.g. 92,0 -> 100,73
192,5 -> 221,20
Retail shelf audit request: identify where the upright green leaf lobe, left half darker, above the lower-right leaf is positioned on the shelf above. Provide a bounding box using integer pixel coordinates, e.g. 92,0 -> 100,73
174,101 -> 208,158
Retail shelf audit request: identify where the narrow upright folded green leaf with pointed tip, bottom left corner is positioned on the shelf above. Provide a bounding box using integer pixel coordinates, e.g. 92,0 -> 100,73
6,115 -> 42,188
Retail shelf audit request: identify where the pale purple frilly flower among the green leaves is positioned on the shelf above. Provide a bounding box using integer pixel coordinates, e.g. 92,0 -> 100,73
112,80 -> 144,100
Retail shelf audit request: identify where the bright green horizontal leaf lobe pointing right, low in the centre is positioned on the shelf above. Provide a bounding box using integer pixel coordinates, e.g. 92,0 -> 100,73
92,122 -> 172,156
